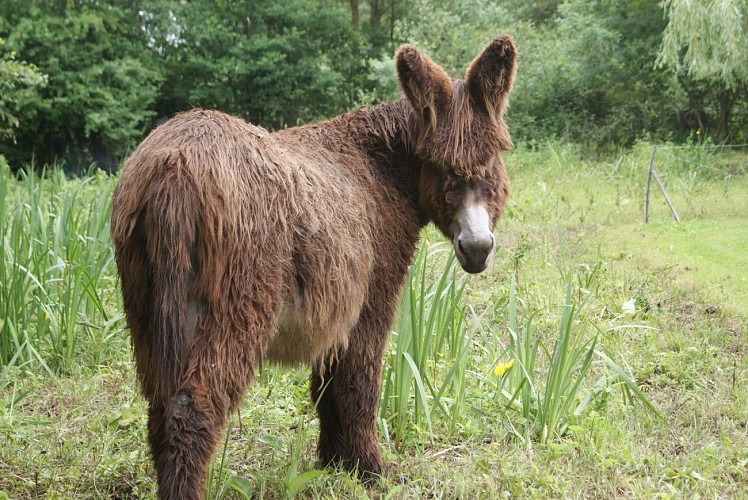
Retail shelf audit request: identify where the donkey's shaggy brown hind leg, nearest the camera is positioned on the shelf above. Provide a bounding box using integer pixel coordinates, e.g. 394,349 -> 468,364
148,318 -> 261,500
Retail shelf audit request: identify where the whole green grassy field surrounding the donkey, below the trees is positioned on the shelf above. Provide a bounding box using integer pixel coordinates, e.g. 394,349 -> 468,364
0,144 -> 748,498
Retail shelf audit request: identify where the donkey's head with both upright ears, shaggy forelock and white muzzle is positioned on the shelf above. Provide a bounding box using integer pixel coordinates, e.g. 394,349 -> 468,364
395,36 -> 517,273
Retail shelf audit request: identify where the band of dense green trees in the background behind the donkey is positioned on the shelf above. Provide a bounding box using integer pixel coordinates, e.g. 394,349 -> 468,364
0,0 -> 748,170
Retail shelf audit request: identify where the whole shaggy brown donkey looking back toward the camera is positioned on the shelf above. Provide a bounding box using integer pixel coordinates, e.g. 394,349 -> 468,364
111,36 -> 516,499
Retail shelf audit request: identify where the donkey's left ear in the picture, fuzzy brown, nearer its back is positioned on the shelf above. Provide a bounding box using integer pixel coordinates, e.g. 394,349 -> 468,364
395,45 -> 454,129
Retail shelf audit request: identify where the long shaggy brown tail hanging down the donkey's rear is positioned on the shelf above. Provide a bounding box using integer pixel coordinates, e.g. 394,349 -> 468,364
112,150 -> 200,403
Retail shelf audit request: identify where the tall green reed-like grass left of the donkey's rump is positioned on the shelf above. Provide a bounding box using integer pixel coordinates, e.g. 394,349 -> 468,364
0,165 -> 122,376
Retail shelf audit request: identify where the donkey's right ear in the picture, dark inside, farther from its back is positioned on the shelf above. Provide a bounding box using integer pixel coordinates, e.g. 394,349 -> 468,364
465,35 -> 517,120
